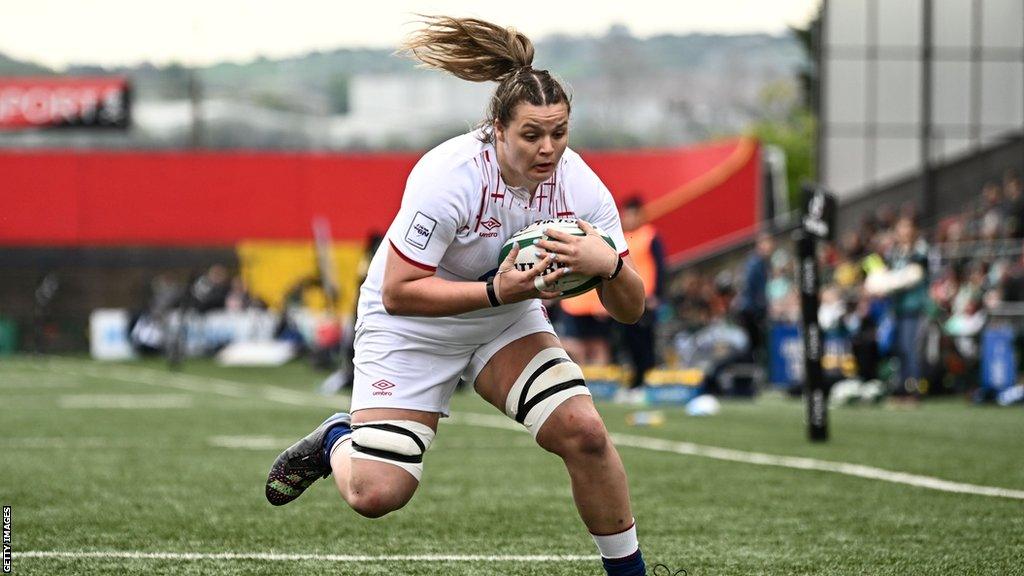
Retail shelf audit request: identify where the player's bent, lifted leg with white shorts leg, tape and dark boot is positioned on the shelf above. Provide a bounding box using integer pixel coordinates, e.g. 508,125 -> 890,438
266,329 -> 462,518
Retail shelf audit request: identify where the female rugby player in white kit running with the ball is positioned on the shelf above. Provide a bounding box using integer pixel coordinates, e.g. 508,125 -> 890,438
266,16 -> 644,575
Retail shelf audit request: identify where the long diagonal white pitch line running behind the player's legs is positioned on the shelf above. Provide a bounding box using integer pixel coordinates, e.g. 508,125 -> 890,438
19,361 -> 1024,500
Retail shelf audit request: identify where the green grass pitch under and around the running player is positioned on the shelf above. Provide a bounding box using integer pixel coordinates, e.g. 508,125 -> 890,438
0,357 -> 1024,576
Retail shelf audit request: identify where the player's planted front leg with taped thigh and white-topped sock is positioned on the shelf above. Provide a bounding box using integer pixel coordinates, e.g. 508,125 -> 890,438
471,315 -> 644,575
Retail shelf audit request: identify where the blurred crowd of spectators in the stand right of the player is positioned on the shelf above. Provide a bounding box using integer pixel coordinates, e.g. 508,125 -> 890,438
663,171 -> 1024,404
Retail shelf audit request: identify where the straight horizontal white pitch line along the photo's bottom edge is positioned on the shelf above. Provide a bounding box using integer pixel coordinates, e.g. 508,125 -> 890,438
13,550 -> 600,562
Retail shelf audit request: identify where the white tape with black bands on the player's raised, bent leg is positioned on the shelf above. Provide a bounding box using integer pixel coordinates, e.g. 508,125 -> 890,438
352,420 -> 434,480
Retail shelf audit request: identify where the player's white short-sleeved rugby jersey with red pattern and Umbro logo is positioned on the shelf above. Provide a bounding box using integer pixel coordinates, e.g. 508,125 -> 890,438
358,131 -> 629,343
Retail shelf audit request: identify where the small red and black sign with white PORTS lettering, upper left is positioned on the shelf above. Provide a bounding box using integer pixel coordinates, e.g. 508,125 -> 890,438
0,76 -> 131,130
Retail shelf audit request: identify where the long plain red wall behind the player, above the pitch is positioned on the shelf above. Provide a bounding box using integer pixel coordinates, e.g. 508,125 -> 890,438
0,139 -> 761,261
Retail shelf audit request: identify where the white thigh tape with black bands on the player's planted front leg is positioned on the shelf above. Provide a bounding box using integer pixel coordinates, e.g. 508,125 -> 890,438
505,347 -> 590,438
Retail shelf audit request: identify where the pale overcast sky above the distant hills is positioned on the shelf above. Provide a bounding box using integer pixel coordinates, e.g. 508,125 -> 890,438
0,0 -> 820,68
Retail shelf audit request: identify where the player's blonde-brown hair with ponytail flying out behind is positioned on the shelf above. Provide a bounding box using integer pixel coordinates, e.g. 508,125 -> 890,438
398,16 -> 571,141
